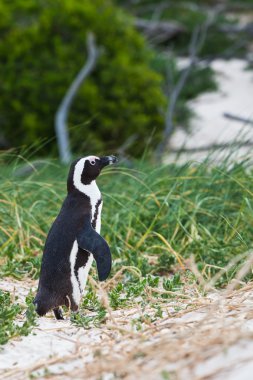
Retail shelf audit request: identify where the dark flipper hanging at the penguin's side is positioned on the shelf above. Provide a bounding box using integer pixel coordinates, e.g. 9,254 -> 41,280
77,217 -> 112,281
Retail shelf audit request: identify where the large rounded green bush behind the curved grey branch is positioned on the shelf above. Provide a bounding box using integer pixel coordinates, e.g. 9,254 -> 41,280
0,0 -> 165,154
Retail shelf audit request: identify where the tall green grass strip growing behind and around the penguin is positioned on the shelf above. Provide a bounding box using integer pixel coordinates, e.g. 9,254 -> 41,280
0,152 -> 253,343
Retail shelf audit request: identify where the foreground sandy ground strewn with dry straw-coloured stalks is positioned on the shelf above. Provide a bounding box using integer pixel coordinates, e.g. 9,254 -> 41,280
0,279 -> 253,380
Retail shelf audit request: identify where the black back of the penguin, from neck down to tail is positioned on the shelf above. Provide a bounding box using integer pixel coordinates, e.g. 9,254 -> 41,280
35,191 -> 91,315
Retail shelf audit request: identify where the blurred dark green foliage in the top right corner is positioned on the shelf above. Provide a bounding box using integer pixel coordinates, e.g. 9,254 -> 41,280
115,0 -> 252,59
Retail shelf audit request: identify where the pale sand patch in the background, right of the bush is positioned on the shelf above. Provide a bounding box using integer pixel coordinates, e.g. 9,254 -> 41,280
166,59 -> 253,162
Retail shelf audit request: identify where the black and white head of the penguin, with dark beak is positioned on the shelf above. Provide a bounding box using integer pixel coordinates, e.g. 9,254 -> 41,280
68,156 -> 117,191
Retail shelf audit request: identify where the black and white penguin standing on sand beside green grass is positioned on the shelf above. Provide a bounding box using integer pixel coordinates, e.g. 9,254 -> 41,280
34,156 -> 117,319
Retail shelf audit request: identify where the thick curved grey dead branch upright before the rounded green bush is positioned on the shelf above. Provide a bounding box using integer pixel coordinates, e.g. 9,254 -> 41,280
55,33 -> 99,164
